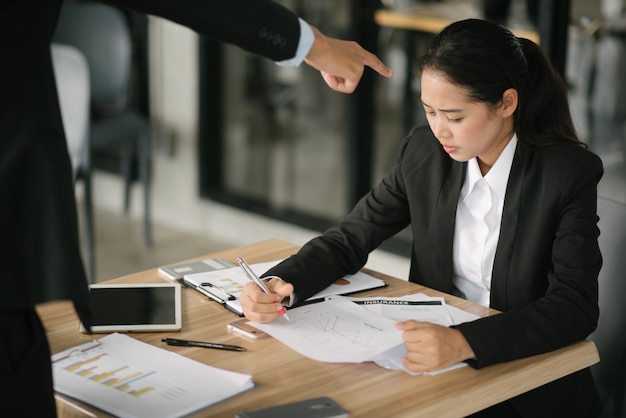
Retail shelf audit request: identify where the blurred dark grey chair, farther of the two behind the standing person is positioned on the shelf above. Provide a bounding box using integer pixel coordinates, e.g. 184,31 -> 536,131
53,2 -> 152,247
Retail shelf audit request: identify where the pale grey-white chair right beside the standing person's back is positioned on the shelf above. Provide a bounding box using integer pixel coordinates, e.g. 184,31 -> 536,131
51,44 -> 95,283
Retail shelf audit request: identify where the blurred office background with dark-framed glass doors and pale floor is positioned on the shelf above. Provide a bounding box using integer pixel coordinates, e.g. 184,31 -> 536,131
63,0 -> 626,281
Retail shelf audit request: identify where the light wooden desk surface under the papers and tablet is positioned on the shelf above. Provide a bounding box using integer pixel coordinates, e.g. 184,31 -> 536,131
38,240 -> 599,418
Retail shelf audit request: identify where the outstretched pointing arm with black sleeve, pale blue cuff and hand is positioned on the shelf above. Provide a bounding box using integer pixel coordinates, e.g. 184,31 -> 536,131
106,0 -> 391,93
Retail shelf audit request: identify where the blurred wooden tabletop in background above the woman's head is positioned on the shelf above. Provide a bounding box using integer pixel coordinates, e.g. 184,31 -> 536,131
374,0 -> 539,44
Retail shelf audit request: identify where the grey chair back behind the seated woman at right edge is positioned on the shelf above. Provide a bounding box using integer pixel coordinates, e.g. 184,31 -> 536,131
589,197 -> 626,414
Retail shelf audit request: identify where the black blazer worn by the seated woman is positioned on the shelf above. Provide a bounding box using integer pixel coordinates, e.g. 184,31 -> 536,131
267,127 -> 603,417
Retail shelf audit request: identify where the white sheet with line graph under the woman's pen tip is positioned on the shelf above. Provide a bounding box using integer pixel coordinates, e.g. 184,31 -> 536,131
249,299 -> 402,363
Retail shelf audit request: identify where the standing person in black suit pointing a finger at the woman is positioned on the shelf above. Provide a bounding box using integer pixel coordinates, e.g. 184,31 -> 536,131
0,0 -> 391,417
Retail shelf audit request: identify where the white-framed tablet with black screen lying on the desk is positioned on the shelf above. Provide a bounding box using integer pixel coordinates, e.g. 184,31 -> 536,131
80,283 -> 182,332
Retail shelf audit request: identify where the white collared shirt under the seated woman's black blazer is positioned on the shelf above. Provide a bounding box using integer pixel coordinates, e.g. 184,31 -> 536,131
453,135 -> 517,306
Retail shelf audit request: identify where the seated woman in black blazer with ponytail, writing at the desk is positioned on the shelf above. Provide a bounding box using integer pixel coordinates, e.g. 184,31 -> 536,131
241,19 -> 603,418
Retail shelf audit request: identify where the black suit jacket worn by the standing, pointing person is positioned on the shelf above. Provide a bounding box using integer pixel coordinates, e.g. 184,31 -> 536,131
0,0 -> 300,323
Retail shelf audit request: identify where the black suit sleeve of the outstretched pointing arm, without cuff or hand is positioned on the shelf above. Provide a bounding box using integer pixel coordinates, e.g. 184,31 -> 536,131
106,0 -> 300,61
